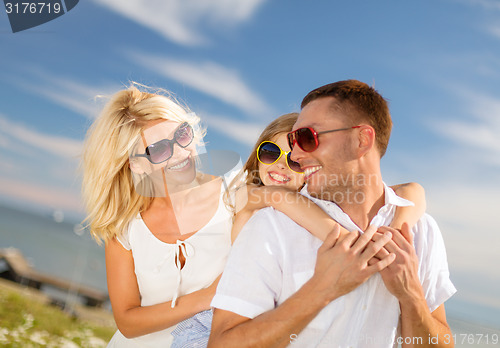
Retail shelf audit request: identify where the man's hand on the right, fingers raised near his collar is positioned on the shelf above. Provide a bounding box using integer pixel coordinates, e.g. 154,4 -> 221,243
369,223 -> 425,302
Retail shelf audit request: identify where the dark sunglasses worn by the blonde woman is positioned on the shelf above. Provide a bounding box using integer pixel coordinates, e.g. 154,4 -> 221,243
135,122 -> 194,164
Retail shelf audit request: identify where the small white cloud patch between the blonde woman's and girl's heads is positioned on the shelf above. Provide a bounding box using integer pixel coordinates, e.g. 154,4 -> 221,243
202,113 -> 265,147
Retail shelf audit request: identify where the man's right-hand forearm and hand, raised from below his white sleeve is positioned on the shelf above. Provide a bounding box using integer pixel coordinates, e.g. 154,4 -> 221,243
369,223 -> 454,348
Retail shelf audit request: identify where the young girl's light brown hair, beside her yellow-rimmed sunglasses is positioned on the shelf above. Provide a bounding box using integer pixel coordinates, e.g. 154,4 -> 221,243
224,112 -> 299,212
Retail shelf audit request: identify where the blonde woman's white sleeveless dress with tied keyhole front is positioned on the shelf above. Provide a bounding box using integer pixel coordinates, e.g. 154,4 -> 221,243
108,181 -> 232,348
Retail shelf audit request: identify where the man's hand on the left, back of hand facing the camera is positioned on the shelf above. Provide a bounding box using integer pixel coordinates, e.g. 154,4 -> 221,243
309,225 -> 395,303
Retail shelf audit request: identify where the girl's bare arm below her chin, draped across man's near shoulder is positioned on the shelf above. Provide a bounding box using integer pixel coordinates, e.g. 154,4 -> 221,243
231,186 -> 347,242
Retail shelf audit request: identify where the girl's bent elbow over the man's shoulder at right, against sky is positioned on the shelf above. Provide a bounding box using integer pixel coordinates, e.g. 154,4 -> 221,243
390,182 -> 426,229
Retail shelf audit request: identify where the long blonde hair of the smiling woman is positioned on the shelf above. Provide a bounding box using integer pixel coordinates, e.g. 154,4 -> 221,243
82,83 -> 205,243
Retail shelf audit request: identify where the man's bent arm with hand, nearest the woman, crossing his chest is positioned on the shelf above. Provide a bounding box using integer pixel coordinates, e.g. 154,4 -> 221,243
208,226 -> 395,348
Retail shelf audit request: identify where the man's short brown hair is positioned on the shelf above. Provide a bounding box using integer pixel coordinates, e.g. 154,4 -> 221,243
301,80 -> 392,157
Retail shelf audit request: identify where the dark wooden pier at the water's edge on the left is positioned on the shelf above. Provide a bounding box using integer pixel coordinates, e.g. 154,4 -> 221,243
0,248 -> 109,307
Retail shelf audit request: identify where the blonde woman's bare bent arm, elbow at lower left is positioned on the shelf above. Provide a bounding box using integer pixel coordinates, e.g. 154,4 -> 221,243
105,238 -> 218,338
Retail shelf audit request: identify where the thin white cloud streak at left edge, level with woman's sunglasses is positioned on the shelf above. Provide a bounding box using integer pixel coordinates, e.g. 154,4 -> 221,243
0,115 -> 82,158
